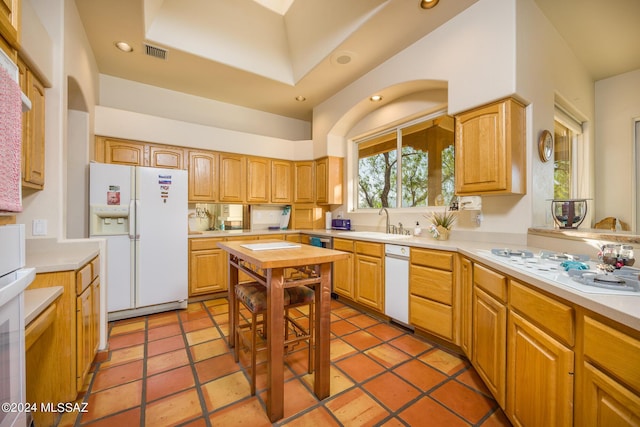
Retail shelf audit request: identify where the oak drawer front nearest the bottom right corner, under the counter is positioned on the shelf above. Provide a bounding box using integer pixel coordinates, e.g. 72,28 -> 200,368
584,316 -> 640,393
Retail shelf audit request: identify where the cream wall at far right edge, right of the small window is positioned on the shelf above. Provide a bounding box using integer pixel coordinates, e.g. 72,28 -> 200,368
595,70 -> 640,229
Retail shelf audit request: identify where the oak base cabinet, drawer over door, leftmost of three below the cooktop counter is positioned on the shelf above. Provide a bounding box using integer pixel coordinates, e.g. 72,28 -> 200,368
471,264 -> 507,408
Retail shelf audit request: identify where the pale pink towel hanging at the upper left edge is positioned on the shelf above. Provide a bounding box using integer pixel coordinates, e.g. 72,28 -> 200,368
0,67 -> 22,212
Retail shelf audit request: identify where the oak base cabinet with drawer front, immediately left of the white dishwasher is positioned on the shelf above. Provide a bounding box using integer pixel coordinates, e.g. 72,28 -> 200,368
354,241 -> 384,313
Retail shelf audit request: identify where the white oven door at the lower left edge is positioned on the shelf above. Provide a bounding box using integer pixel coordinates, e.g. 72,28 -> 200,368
0,292 -> 27,427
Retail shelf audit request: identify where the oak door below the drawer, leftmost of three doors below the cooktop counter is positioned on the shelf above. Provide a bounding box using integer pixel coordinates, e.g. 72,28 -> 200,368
472,287 -> 507,408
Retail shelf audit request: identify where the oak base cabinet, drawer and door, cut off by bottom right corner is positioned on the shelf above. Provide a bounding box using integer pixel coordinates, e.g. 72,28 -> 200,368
575,314 -> 640,427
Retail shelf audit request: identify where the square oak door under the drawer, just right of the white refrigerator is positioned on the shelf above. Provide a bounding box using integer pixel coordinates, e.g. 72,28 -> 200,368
189,249 -> 227,296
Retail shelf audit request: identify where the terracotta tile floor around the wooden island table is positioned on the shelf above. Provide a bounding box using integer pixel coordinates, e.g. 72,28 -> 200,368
58,299 -> 510,427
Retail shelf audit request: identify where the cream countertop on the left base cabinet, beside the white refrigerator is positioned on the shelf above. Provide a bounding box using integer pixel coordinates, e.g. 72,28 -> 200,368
26,239 -> 100,273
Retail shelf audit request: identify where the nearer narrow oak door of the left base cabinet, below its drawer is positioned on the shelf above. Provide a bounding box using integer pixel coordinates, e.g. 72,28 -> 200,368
76,286 -> 93,390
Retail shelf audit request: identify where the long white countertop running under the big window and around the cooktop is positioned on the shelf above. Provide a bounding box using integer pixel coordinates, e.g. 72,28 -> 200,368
190,230 -> 640,331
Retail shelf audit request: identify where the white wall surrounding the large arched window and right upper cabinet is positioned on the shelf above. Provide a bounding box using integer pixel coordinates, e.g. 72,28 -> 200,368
313,0 -> 593,238
